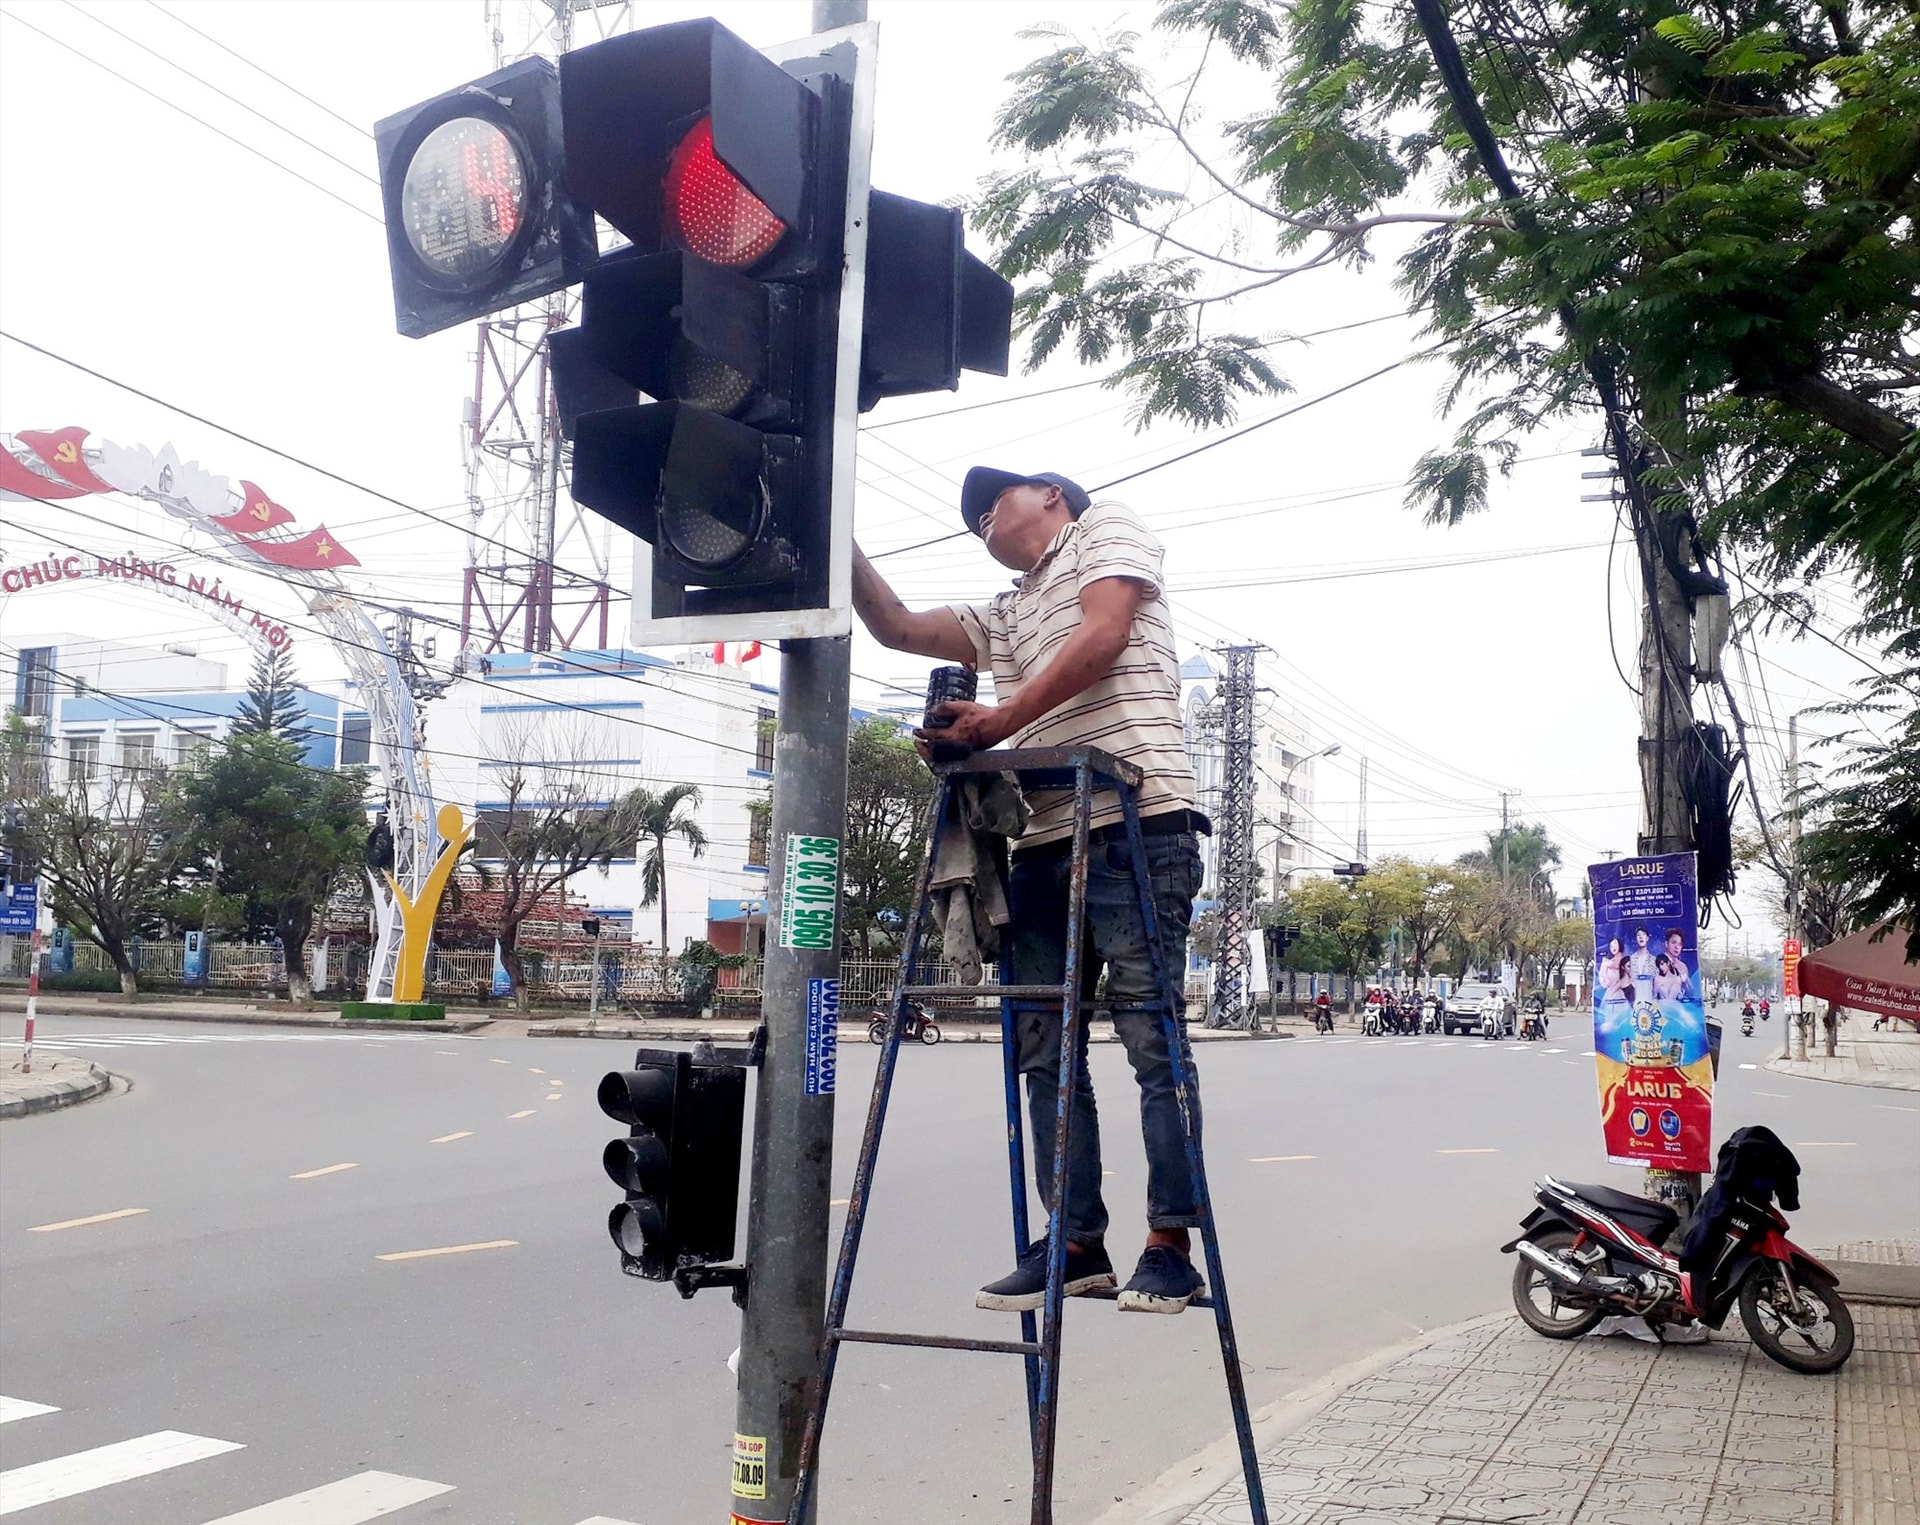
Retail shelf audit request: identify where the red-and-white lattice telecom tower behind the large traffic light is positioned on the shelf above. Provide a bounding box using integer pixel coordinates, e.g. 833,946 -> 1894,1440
461,0 -> 634,663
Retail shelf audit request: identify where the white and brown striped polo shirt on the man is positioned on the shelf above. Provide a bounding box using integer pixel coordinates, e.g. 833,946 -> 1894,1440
950,503 -> 1194,847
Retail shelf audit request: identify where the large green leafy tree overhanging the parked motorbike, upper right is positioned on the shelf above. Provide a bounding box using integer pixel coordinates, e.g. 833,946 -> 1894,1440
973,0 -> 1920,914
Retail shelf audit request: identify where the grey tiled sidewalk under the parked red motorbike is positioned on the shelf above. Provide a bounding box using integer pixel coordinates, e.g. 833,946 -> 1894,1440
1181,1308 -> 1920,1525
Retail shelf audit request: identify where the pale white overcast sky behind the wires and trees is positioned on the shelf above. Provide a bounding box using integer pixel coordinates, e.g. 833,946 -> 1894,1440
0,0 -> 1862,949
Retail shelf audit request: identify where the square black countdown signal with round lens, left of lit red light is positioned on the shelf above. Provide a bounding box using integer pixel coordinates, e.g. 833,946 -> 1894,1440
374,58 -> 595,338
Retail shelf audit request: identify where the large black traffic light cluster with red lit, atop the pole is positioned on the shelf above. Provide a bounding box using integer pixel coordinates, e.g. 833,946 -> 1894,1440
366,19 -> 1014,645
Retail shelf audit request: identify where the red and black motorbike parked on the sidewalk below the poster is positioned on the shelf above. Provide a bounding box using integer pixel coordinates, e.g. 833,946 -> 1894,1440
1500,1127 -> 1853,1373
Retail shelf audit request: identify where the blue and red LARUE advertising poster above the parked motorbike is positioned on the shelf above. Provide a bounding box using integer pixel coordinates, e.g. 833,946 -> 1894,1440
1586,853 -> 1713,1170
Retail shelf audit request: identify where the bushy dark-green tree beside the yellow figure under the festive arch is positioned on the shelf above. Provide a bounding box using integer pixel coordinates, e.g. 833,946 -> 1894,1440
179,730 -> 367,1001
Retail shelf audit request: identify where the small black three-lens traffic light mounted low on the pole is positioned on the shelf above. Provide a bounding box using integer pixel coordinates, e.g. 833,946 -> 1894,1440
599,1049 -> 747,1281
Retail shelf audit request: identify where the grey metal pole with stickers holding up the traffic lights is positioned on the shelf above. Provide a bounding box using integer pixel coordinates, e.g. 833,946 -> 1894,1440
728,20 -> 866,1521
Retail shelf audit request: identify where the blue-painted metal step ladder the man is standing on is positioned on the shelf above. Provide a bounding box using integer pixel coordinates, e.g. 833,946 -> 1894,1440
787,747 -> 1267,1525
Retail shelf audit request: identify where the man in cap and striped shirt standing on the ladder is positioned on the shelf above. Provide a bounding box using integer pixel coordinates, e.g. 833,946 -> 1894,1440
852,467 -> 1212,1314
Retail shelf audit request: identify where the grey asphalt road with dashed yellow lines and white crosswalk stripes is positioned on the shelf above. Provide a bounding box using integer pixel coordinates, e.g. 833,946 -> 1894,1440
0,1018 -> 1920,1525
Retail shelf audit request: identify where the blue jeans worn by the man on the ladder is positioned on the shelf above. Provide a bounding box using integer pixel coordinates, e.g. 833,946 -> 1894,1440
1000,832 -> 1200,1245
